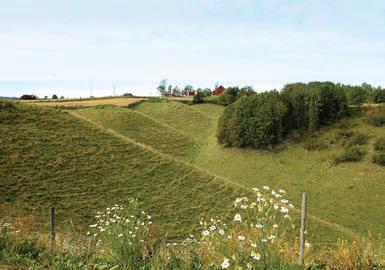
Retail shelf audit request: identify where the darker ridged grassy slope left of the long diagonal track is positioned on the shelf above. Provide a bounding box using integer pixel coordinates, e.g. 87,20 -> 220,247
0,105 -> 239,237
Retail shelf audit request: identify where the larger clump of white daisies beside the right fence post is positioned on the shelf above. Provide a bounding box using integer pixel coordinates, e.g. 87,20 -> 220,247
200,186 -> 294,269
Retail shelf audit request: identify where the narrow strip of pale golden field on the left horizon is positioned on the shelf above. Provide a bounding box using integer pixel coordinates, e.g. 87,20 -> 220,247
22,97 -> 144,108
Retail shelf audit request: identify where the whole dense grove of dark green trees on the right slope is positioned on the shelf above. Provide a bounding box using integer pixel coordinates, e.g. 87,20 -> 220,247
216,82 -> 348,148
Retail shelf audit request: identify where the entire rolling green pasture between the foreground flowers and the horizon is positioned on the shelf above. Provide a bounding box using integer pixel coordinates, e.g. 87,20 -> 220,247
0,101 -> 385,243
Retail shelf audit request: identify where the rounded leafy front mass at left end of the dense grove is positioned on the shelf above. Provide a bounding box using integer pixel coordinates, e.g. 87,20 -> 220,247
217,92 -> 285,148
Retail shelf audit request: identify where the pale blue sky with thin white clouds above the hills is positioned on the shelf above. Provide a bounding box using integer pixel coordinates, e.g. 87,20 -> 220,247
0,0 -> 385,97
